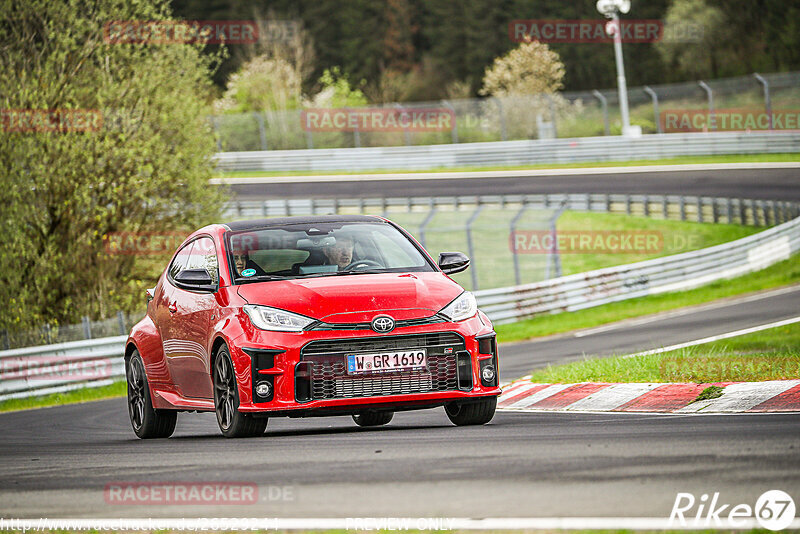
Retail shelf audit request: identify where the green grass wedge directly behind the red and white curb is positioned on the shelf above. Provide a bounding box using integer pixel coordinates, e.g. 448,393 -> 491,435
531,323 -> 800,386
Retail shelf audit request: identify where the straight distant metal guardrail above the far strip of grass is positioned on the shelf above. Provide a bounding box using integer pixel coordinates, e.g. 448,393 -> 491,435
214,131 -> 800,171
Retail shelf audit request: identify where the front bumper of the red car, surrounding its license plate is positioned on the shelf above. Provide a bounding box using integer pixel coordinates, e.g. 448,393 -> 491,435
230,312 -> 501,417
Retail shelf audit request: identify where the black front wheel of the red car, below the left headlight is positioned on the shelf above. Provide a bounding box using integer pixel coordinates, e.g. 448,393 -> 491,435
213,345 -> 267,438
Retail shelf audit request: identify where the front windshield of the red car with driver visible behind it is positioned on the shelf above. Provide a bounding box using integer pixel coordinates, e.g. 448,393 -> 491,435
226,223 -> 434,283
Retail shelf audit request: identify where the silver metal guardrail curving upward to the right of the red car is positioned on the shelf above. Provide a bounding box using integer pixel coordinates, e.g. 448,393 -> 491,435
475,218 -> 800,324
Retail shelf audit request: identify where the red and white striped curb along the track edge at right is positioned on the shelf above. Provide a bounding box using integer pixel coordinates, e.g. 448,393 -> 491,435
497,377 -> 800,413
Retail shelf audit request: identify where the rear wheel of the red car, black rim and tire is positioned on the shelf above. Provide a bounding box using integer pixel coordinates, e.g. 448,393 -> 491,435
125,350 -> 178,439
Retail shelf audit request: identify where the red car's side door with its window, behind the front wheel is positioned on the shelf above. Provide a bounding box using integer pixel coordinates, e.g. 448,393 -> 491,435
162,237 -> 219,399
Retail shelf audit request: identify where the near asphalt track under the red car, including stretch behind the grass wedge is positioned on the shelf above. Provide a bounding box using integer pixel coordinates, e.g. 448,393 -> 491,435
0,287 -> 800,518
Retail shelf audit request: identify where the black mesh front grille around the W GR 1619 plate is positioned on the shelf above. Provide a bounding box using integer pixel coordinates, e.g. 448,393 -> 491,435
298,332 -> 465,400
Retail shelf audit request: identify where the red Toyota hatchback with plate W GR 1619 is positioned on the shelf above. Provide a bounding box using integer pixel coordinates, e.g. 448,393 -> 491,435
125,216 -> 500,438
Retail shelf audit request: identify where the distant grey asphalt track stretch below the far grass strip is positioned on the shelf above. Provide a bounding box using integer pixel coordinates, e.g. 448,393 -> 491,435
229,167 -> 800,200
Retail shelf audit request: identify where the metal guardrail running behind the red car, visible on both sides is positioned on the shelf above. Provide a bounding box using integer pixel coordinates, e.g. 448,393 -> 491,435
0,209 -> 800,400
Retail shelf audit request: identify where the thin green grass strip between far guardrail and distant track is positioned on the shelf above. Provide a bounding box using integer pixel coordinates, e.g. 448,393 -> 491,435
216,153 -> 800,178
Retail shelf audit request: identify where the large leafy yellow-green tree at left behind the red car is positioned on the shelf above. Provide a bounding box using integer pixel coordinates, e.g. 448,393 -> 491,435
0,0 -> 223,336
